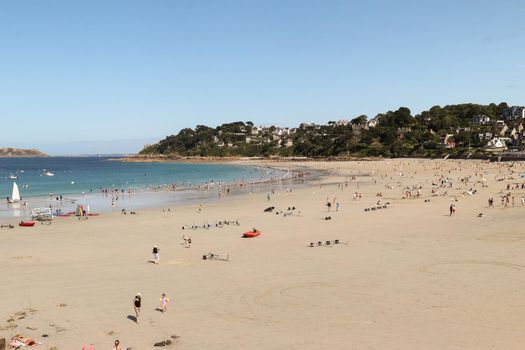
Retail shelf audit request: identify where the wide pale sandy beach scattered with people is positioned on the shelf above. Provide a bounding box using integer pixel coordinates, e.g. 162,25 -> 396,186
0,159 -> 525,350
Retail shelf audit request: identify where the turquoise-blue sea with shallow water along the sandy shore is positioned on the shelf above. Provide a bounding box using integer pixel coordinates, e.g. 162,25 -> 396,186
0,157 -> 290,217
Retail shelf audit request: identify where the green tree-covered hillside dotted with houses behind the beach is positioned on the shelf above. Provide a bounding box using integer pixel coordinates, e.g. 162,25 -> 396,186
140,103 -> 523,157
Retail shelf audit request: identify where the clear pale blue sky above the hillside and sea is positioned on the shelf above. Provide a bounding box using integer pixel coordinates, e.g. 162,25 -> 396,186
0,0 -> 525,154
